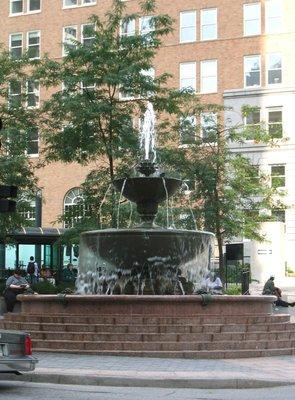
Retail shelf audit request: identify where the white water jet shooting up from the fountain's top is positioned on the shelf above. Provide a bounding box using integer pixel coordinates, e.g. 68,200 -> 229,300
140,102 -> 156,162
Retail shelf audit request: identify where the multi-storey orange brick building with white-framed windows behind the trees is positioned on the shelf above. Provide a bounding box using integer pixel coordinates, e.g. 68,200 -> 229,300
0,0 -> 295,282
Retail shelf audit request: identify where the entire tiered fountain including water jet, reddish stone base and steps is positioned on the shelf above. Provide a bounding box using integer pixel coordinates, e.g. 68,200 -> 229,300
4,105 -> 295,358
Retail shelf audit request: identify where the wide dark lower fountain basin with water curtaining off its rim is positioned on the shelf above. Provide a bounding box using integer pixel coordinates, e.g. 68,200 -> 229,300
76,229 -> 214,294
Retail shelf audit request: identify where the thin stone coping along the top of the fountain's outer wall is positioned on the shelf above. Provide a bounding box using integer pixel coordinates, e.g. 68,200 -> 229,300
17,294 -> 276,304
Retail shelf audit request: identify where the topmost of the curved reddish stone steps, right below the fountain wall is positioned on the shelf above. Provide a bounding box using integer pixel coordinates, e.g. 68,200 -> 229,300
5,314 -> 290,325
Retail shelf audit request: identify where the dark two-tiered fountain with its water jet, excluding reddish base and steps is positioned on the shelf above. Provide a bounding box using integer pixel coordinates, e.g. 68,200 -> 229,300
76,103 -> 214,295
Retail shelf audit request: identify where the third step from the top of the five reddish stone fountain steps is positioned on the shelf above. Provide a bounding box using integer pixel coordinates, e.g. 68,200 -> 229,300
27,331 -> 295,342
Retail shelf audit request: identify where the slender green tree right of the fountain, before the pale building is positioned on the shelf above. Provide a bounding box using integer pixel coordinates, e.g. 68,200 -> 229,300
162,102 -> 285,276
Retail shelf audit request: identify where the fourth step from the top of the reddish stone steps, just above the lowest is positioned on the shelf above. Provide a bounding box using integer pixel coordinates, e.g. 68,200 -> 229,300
32,339 -> 295,352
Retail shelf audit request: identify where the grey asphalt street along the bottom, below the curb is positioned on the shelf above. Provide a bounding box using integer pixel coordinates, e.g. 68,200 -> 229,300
0,381 -> 295,400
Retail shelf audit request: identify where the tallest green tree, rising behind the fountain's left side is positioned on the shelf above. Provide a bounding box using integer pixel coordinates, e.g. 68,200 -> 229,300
36,0 -> 183,231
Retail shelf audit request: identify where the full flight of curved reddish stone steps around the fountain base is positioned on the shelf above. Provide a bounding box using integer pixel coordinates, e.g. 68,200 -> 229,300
0,313 -> 295,358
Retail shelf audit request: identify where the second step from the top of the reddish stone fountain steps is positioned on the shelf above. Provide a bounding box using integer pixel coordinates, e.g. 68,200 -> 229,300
0,319 -> 295,334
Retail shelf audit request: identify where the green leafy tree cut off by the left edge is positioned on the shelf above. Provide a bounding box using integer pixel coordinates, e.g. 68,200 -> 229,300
0,50 -> 38,241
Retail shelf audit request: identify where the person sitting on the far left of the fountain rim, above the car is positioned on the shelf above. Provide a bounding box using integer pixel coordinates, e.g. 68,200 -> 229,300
4,268 -> 30,312
